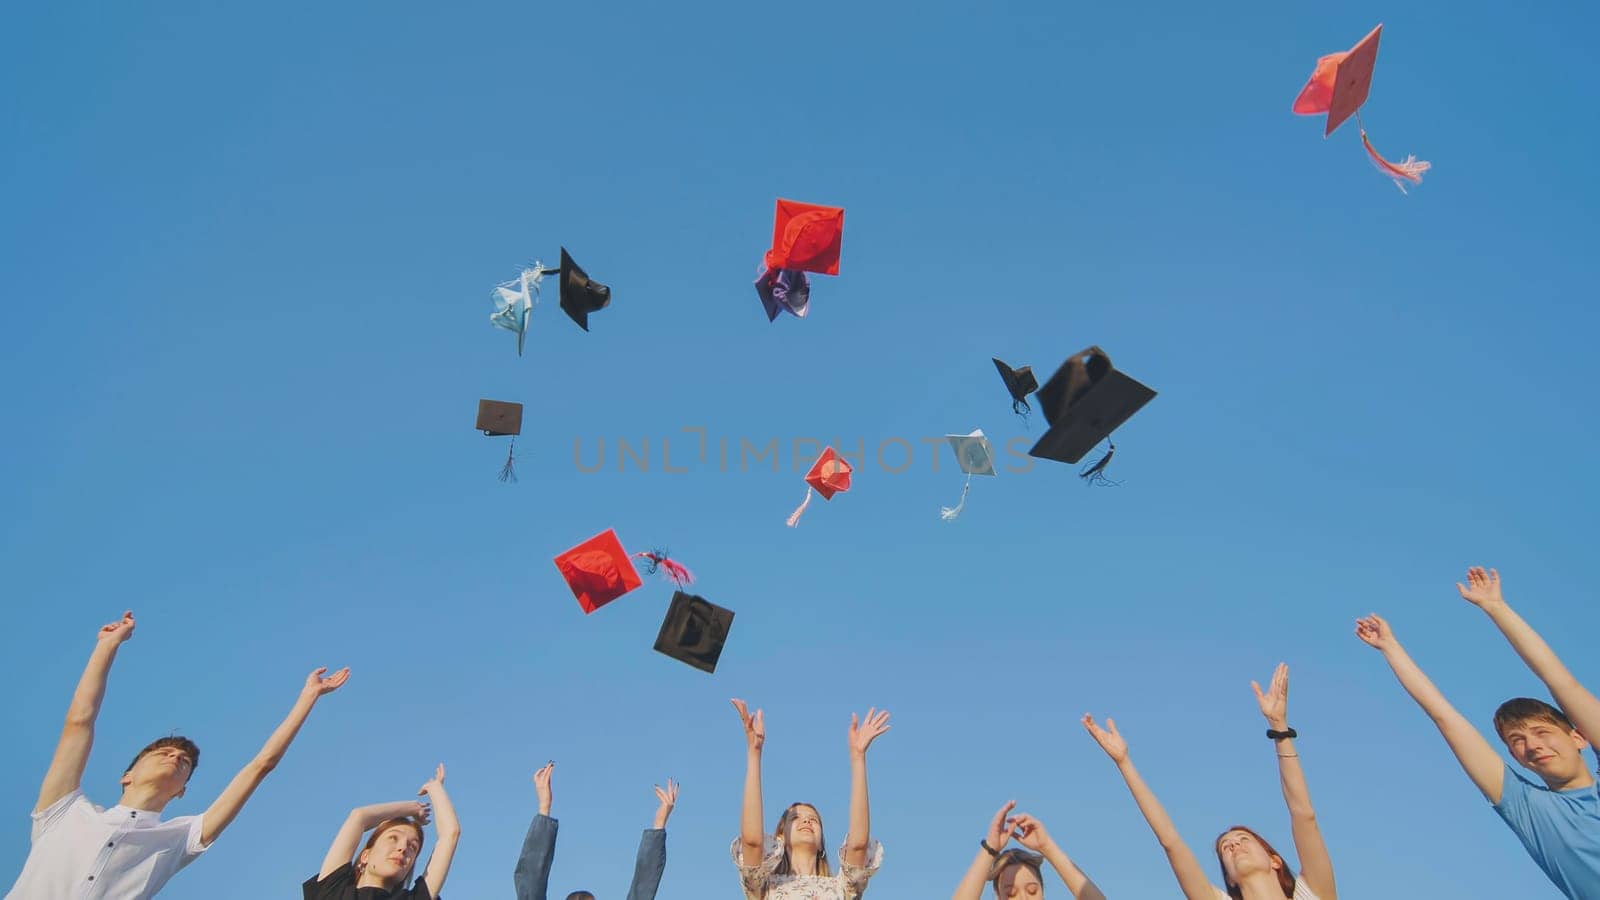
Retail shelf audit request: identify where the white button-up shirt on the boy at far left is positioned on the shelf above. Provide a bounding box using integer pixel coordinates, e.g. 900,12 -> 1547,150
6,791 -> 205,900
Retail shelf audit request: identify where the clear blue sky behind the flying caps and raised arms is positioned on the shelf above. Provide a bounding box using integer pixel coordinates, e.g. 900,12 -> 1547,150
0,2 -> 1600,900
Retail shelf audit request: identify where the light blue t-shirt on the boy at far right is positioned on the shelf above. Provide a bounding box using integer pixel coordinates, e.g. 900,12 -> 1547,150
1494,764 -> 1600,900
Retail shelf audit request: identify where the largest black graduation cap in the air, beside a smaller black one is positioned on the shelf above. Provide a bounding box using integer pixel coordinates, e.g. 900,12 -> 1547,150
1027,348 -> 1155,463
